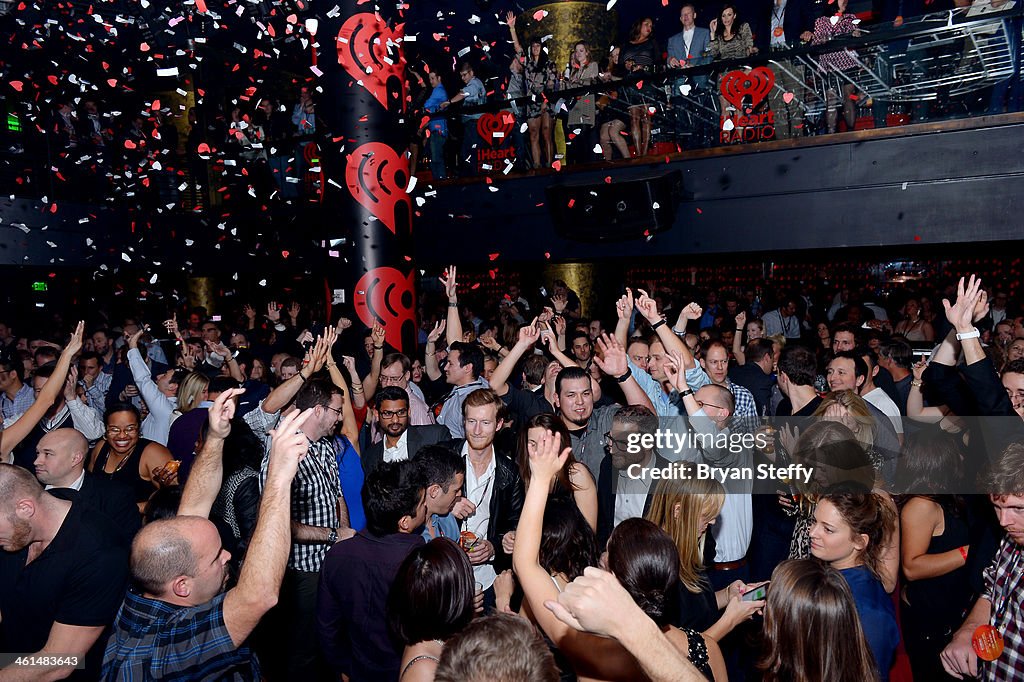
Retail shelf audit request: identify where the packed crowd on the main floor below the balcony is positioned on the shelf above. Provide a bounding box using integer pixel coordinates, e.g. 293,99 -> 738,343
0,261 -> 1024,682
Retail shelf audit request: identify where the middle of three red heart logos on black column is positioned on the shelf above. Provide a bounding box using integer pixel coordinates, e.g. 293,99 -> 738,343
345,142 -> 413,235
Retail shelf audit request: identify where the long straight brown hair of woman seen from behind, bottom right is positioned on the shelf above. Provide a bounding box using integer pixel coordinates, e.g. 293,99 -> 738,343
758,559 -> 879,682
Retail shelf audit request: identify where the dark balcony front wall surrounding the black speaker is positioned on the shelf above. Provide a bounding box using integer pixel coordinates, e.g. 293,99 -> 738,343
416,124 -> 1024,264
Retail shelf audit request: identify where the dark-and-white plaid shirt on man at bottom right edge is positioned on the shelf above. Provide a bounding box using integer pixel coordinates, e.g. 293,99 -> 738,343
978,537 -> 1024,682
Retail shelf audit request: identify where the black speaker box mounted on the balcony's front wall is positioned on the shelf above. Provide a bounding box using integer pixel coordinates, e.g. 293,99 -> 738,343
547,170 -> 684,242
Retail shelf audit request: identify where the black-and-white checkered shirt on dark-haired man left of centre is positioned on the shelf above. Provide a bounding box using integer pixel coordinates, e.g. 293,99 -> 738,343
260,432 -> 341,573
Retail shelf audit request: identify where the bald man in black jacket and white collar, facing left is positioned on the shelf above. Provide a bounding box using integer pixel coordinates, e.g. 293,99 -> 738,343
35,429 -> 142,547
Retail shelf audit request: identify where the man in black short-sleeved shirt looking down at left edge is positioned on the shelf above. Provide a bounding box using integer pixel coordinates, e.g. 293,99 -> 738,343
0,464 -> 128,681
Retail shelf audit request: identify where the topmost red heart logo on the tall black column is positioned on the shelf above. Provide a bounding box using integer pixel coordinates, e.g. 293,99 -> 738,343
338,12 -> 406,112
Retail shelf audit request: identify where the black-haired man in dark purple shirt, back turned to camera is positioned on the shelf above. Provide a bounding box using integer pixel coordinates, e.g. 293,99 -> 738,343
313,462 -> 427,682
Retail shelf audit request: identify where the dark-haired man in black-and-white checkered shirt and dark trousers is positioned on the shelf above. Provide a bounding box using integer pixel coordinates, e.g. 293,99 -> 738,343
260,374 -> 353,680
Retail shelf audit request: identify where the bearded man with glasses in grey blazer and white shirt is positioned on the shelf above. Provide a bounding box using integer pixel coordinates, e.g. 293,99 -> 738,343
361,386 -> 450,475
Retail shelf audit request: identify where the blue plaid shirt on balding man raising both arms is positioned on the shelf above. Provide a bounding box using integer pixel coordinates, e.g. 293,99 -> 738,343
101,592 -> 260,682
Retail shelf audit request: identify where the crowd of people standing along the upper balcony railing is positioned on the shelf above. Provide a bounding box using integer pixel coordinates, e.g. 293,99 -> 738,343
409,0 -> 1017,179
